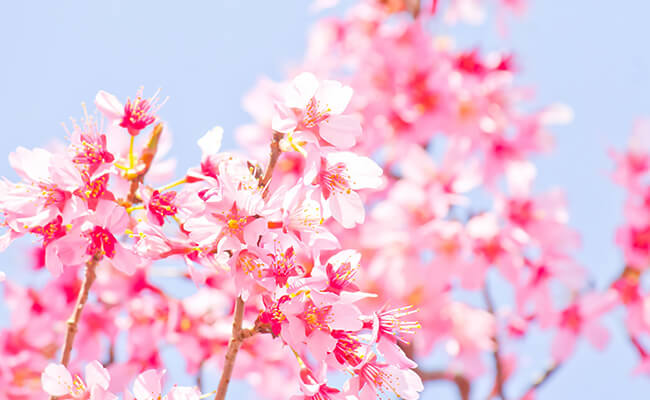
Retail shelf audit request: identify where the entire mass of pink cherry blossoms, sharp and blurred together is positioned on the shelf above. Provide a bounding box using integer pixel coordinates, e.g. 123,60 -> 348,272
0,0 -> 650,400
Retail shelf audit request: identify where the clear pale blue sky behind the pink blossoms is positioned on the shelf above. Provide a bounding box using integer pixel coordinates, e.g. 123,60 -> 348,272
0,0 -> 650,399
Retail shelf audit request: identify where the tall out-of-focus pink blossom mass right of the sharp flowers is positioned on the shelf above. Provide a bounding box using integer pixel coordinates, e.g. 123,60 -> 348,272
238,1 -> 618,398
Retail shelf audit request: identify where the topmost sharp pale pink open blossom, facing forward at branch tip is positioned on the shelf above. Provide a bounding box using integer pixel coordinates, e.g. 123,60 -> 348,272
273,72 -> 361,149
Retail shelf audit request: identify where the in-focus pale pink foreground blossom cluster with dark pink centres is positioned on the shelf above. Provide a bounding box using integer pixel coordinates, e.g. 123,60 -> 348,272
0,73 -> 423,400
